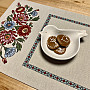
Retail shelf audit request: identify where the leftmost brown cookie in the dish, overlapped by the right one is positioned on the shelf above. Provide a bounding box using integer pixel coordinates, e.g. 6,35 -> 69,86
47,36 -> 59,50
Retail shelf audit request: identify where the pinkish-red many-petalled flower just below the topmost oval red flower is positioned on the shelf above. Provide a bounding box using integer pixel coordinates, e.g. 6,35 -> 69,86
13,13 -> 28,25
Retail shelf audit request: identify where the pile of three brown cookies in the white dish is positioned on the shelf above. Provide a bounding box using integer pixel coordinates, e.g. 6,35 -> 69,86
47,35 -> 70,55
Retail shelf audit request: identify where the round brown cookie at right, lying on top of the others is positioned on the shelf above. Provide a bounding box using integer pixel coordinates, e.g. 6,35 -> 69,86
57,35 -> 70,47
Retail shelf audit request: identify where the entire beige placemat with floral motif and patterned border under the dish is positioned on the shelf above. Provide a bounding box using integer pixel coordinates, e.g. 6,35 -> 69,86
0,0 -> 90,90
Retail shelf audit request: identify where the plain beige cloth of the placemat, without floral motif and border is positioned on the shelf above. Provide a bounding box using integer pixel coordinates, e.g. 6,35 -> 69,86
0,0 -> 90,90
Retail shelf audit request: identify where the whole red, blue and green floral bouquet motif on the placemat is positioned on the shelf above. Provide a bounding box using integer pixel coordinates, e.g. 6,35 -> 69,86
0,3 -> 40,64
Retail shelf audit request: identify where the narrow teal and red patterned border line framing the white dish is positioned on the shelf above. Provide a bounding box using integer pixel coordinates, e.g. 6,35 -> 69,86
23,14 -> 90,90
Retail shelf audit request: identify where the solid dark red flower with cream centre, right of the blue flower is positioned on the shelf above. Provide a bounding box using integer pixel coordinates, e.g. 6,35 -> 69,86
17,25 -> 31,36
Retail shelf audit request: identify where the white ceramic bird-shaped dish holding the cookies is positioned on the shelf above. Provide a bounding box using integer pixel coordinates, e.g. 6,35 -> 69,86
40,25 -> 87,60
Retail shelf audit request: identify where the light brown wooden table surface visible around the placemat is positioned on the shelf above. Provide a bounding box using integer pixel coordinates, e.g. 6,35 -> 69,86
0,0 -> 90,90
